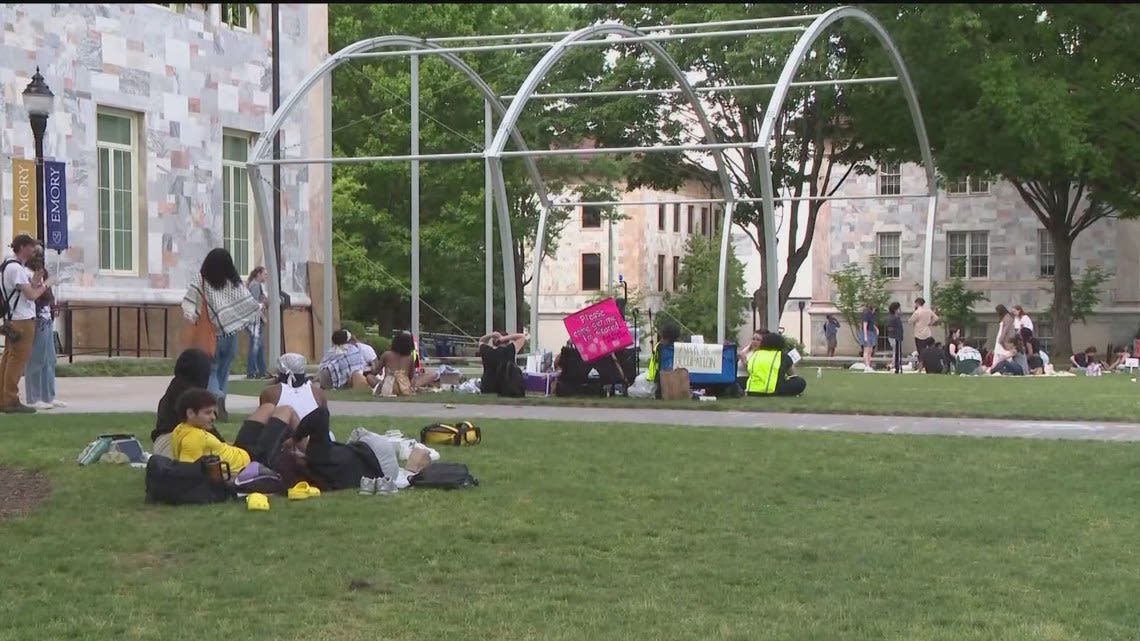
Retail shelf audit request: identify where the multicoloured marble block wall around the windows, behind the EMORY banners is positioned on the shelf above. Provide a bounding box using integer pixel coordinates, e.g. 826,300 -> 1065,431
0,3 -> 327,303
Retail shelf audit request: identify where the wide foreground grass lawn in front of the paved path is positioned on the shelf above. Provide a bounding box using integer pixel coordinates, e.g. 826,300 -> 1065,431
0,410 -> 1140,641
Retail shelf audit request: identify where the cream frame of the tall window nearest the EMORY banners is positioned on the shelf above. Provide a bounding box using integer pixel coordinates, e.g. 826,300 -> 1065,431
95,106 -> 143,276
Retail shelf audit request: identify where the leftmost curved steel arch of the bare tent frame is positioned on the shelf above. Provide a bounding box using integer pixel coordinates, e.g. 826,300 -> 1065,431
246,35 -> 551,362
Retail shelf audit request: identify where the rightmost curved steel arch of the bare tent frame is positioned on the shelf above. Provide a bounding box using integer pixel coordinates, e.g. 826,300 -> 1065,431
756,7 -> 938,328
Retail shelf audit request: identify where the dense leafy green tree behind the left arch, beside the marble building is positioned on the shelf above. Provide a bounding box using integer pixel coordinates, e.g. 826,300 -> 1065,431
329,5 -> 621,334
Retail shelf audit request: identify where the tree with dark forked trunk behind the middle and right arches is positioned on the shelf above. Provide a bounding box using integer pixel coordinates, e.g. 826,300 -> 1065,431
568,3 -> 913,317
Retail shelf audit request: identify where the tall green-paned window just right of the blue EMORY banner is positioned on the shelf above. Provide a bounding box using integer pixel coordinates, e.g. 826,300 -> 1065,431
96,109 -> 138,274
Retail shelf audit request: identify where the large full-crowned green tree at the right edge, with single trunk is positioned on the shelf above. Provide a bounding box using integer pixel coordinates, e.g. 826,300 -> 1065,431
873,3 -> 1140,354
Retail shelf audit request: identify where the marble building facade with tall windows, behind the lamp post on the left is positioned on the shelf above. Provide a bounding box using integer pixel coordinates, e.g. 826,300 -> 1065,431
0,3 -> 328,356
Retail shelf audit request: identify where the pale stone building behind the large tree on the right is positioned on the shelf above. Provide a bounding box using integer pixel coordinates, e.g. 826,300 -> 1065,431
805,164 -> 1140,355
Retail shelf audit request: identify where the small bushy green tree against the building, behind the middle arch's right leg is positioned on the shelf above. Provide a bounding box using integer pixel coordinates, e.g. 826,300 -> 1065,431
661,235 -> 749,340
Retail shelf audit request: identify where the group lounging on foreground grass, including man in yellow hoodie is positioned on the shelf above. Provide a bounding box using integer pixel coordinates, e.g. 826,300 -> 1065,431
150,349 -> 399,490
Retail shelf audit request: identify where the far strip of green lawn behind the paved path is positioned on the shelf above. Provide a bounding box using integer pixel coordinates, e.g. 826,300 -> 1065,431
229,370 -> 1140,422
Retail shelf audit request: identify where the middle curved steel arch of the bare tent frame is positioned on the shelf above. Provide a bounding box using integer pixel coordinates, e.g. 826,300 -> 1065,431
486,23 -> 736,344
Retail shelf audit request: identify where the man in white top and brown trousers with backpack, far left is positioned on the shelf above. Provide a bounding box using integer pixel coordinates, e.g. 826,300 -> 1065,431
0,234 -> 52,414
